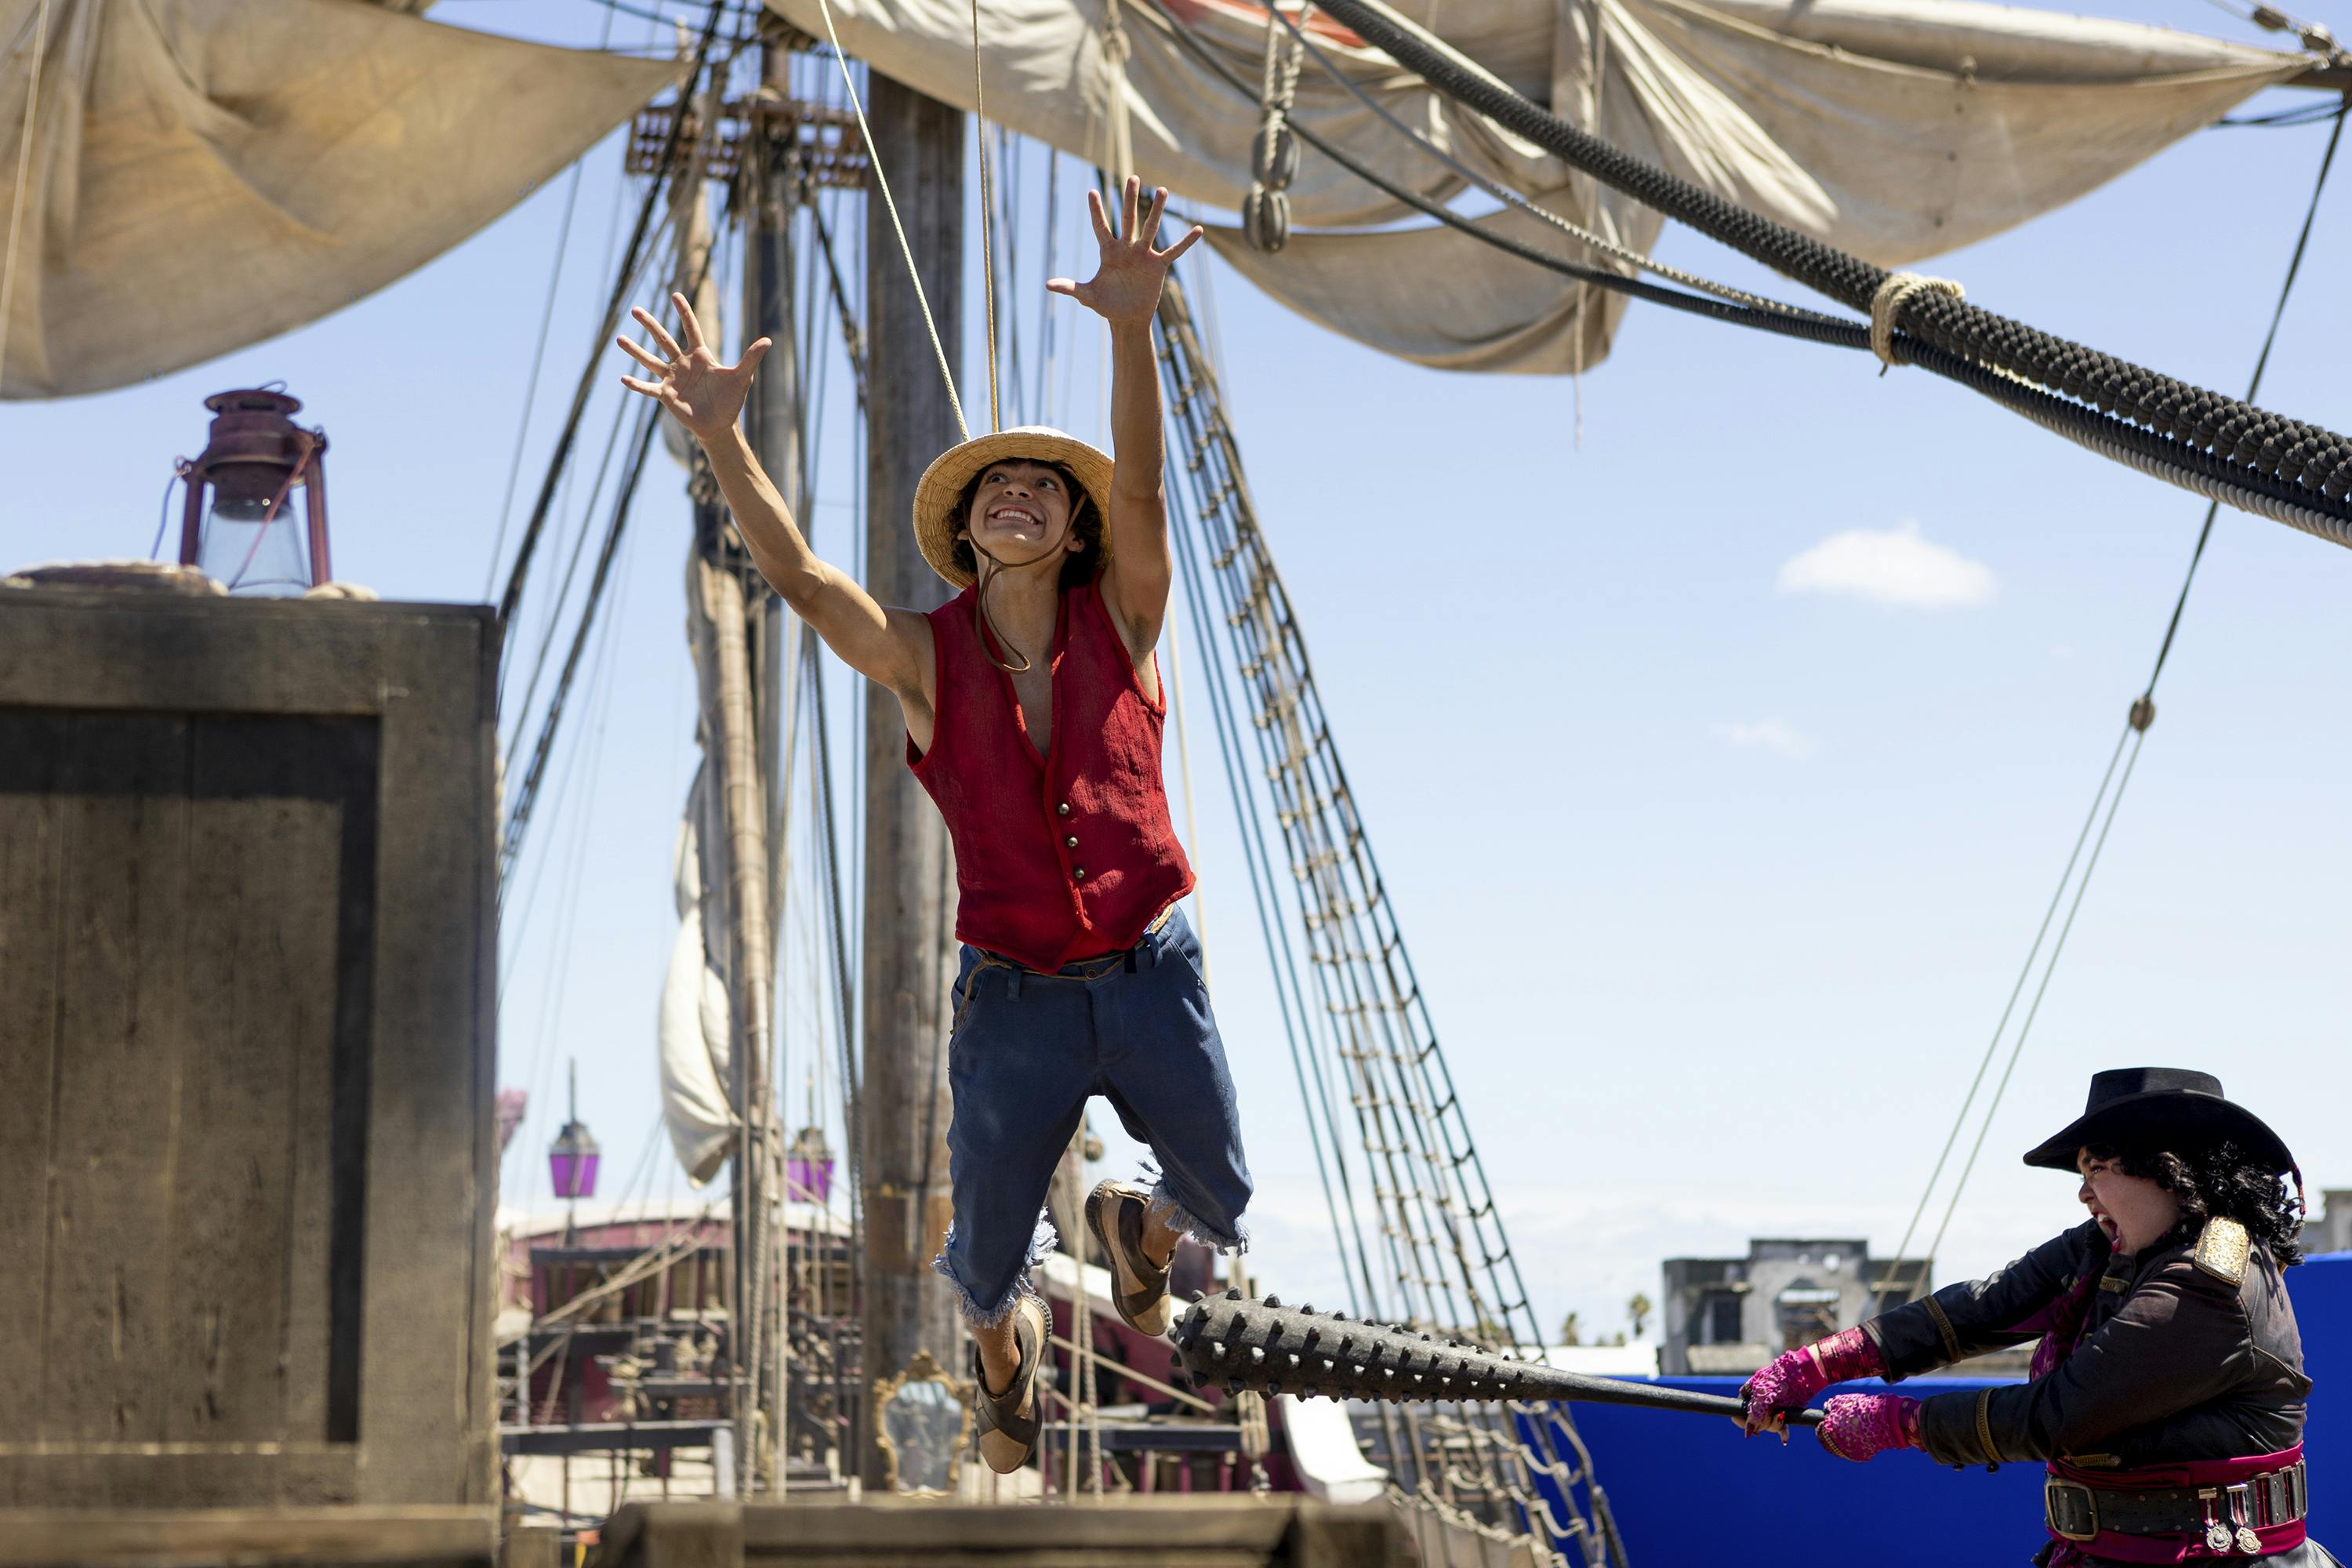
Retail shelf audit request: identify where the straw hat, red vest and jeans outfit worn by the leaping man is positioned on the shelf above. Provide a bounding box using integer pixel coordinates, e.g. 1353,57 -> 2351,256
906,426 -> 1251,1382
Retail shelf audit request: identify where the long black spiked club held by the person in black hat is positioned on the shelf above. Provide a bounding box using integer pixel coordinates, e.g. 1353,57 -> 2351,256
1176,1290 -> 1820,1427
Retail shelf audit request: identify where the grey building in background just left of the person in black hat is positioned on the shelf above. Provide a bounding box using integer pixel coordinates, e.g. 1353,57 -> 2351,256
1658,1239 -> 1933,1377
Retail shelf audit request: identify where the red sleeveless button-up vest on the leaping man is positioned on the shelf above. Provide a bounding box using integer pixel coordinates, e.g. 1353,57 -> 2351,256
906,583 -> 1192,971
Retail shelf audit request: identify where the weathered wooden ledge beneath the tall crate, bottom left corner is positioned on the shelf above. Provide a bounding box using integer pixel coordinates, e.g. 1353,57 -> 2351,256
0,1507 -> 499,1568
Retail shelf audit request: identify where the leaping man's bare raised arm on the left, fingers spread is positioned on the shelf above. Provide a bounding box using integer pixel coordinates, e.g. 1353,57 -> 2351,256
621,294 -> 931,699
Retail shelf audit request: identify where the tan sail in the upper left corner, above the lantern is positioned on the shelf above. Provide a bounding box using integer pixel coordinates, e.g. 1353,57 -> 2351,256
0,0 -> 680,397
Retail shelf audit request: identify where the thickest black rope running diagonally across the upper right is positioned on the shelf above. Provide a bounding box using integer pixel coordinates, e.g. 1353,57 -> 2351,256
1322,0 -> 2352,533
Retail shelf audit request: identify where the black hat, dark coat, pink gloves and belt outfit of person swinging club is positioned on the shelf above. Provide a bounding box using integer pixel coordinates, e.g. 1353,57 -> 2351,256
1740,1067 -> 2336,1568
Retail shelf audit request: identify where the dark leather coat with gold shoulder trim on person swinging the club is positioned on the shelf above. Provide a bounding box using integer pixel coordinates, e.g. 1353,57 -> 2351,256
1863,1220 -> 2312,1467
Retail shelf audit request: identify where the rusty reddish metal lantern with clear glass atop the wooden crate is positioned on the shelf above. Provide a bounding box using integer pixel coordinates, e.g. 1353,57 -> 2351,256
179,388 -> 334,595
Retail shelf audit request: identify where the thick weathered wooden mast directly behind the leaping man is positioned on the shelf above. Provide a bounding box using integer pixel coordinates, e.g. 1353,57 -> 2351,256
861,73 -> 964,1488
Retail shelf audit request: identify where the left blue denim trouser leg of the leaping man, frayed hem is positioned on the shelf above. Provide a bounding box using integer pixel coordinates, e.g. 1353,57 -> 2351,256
938,966 -> 1094,1394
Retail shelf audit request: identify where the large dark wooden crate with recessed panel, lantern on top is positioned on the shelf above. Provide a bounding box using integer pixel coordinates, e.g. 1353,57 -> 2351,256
0,588 -> 496,1509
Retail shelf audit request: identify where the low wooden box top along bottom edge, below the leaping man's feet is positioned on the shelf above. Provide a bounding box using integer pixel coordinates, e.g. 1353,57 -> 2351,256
593,1497 -> 1414,1568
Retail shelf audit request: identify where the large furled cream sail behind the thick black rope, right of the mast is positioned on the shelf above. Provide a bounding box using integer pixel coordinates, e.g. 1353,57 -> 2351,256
769,0 -> 2307,372
